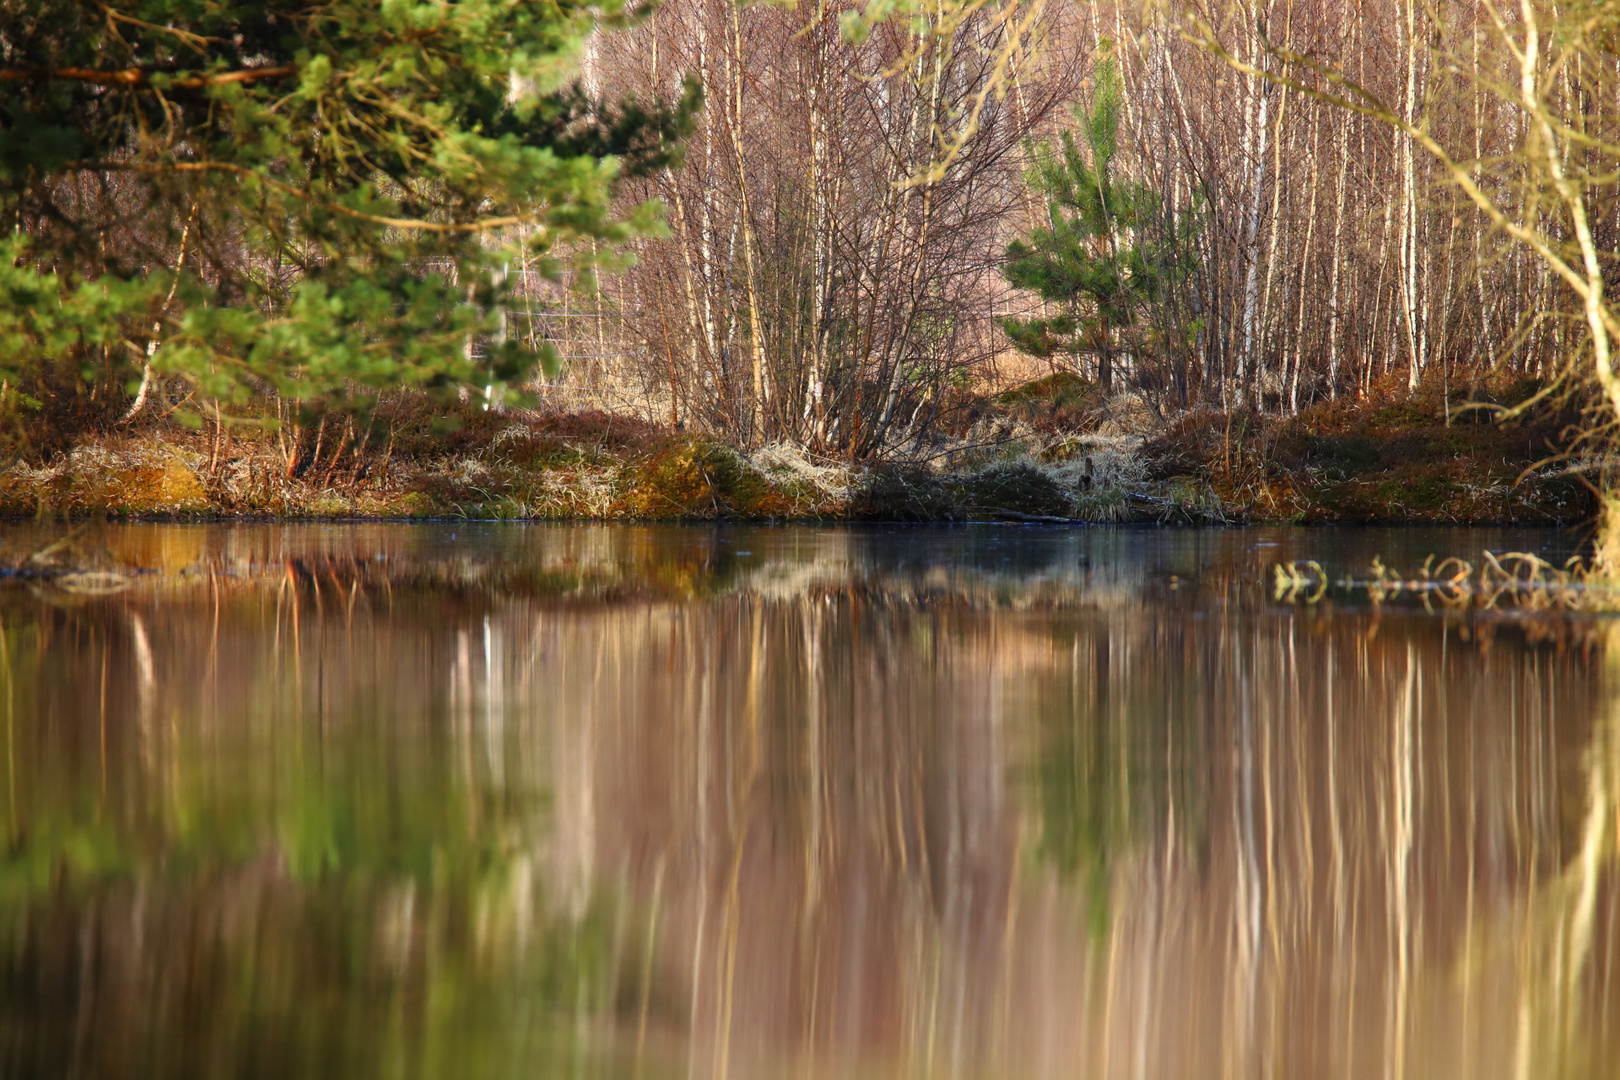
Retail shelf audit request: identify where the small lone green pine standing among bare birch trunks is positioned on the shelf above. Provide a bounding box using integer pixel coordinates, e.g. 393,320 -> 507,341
1001,53 -> 1197,390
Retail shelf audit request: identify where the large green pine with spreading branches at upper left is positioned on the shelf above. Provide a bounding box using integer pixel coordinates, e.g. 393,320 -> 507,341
0,0 -> 700,430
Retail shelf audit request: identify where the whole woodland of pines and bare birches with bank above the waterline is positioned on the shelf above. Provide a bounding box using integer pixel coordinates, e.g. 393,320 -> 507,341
0,0 -> 1620,523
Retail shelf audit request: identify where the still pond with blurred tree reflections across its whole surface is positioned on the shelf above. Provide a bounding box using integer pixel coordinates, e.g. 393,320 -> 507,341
0,523 -> 1620,1080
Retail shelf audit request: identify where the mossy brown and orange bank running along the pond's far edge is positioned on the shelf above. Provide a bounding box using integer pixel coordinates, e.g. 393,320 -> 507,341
0,376 -> 1596,525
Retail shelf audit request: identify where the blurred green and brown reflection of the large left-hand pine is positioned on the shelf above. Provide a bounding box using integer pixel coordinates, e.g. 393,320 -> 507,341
0,559 -> 640,1077
